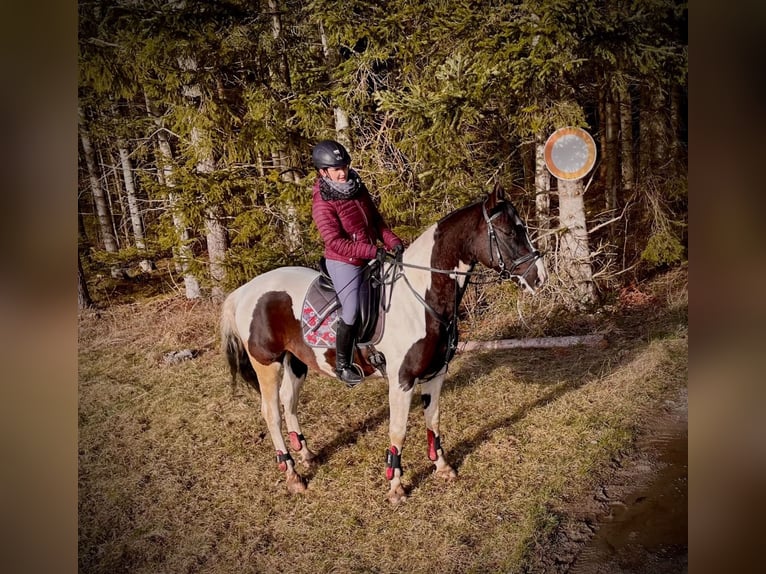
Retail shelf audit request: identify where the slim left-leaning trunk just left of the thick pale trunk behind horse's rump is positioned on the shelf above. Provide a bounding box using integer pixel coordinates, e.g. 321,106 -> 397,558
145,92 -> 202,299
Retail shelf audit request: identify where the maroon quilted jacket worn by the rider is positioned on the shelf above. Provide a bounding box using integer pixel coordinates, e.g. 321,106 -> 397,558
311,179 -> 402,266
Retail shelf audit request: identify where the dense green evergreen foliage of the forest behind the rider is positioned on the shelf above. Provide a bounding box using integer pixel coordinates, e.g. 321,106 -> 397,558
79,0 -> 687,304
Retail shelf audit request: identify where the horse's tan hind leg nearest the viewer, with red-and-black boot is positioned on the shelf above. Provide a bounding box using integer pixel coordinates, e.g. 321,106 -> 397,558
252,361 -> 306,493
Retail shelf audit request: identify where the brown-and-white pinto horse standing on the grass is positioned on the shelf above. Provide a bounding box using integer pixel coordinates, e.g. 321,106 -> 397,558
220,183 -> 546,505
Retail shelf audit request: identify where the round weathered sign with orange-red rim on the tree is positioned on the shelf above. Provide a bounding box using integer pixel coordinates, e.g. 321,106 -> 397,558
545,127 -> 596,181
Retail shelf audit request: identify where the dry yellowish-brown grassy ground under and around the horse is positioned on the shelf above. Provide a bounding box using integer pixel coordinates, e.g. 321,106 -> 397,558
79,270 -> 687,574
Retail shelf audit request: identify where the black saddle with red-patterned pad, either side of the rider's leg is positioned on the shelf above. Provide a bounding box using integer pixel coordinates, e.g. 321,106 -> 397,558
301,257 -> 386,348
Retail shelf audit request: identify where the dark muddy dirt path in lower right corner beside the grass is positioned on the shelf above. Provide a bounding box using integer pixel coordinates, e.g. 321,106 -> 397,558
535,388 -> 688,574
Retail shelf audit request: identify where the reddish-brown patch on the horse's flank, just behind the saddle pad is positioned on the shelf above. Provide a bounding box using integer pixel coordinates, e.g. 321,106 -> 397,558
247,291 -> 319,370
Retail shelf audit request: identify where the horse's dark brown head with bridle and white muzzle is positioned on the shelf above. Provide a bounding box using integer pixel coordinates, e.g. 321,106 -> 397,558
477,182 -> 547,293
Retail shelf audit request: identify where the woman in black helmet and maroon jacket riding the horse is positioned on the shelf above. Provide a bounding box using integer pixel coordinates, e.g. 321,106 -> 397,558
311,140 -> 404,386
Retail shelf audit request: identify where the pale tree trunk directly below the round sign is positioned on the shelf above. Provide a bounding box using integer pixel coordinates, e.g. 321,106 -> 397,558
558,179 -> 596,307
